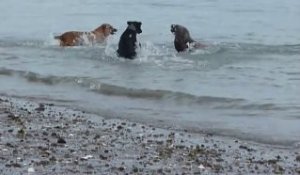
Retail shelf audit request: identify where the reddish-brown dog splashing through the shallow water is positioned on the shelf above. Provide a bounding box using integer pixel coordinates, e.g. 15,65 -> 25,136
54,24 -> 117,46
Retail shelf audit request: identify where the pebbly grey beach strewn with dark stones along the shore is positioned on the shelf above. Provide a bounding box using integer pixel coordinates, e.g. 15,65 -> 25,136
0,97 -> 300,175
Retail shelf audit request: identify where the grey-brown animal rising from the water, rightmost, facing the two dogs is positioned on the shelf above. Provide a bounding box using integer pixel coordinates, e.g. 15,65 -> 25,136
171,24 -> 207,52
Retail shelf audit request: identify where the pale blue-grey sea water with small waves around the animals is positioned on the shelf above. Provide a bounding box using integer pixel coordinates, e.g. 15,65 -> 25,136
0,0 -> 300,147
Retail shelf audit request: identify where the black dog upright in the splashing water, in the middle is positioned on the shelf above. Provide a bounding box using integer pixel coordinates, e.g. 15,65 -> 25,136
117,21 -> 142,59
